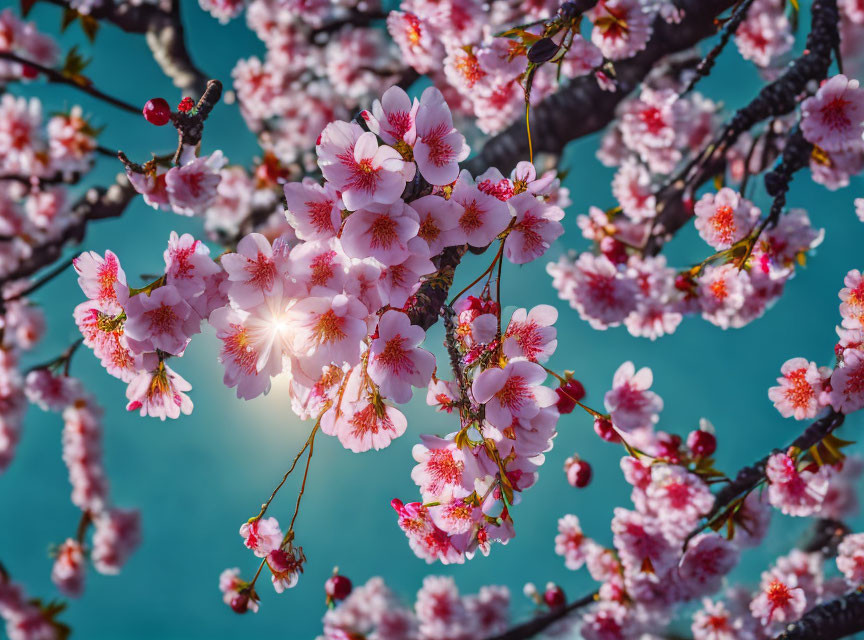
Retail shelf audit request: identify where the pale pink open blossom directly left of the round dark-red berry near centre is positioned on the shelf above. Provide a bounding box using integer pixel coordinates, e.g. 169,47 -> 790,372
471,360 -> 558,429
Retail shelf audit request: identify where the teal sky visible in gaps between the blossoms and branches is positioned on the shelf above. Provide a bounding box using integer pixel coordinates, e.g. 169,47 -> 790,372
0,0 -> 864,640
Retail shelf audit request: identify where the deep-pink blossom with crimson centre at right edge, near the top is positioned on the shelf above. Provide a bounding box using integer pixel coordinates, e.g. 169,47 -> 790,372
801,74 -> 864,151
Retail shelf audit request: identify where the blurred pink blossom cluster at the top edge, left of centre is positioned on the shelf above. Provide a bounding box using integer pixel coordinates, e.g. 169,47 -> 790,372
231,0 -> 403,166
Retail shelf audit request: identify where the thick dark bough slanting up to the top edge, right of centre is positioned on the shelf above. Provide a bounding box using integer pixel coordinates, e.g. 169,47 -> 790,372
469,0 -> 736,172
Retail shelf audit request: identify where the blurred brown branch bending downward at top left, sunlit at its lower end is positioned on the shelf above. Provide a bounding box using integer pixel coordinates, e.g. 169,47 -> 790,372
34,0 -> 207,95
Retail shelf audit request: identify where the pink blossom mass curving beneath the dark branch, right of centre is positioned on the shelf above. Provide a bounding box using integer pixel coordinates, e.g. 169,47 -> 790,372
547,59 -> 822,340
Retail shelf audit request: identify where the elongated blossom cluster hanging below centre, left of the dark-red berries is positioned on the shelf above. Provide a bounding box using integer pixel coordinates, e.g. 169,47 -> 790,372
393,296 -> 559,564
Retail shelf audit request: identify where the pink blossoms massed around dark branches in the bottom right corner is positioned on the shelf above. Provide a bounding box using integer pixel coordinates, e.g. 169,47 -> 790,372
555,362 -> 864,640
